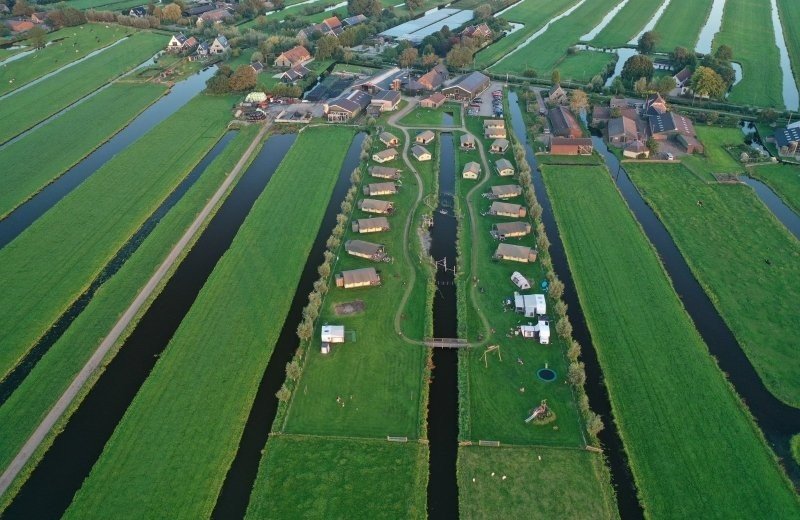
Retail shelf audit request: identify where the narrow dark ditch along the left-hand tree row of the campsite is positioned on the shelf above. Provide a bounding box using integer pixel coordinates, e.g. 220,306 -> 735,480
211,132 -> 366,519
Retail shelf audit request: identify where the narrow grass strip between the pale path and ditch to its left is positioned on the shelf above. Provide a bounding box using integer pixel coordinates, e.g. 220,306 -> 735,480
0,126 -> 259,509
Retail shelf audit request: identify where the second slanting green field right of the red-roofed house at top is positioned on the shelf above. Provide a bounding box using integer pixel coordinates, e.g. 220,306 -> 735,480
491,0 -> 614,77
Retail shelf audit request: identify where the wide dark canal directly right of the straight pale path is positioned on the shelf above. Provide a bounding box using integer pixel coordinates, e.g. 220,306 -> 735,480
3,134 -> 296,519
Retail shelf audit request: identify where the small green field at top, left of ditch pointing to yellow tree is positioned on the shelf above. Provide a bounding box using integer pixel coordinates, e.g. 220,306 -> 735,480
653,0 -> 716,54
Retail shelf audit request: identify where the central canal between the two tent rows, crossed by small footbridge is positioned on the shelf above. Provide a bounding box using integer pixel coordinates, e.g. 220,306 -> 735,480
428,133 -> 458,518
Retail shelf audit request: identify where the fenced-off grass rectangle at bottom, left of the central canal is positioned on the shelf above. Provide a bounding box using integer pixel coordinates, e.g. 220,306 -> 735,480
246,435 -> 428,520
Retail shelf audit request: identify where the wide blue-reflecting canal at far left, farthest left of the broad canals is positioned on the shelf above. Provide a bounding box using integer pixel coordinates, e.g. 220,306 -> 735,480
0,67 -> 216,248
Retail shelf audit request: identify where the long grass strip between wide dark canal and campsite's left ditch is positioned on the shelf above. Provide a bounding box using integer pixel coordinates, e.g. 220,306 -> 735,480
66,127 -> 353,518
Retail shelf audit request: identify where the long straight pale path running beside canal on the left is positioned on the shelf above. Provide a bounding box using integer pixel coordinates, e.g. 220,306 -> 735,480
0,124 -> 271,495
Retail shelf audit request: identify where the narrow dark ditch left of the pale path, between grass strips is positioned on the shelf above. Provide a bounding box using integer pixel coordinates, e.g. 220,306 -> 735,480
0,131 -> 236,406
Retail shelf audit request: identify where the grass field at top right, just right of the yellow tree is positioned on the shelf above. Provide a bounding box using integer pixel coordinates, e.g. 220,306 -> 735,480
714,0 -> 784,108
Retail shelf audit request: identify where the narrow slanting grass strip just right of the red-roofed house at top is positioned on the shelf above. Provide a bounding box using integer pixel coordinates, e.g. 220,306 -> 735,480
475,0 -> 578,69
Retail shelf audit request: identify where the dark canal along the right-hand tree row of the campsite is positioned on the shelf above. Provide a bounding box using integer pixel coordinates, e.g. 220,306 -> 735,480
509,92 -> 644,519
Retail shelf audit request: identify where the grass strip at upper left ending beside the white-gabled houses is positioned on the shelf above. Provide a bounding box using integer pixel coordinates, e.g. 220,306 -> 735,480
0,32 -> 167,143
